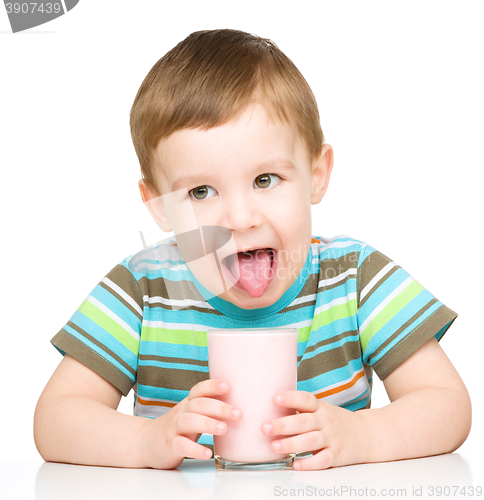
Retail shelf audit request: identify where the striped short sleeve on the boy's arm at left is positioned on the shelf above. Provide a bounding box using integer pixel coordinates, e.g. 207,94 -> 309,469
51,259 -> 143,396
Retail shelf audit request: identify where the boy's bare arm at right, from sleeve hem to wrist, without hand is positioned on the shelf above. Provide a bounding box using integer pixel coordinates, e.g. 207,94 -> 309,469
360,338 -> 472,462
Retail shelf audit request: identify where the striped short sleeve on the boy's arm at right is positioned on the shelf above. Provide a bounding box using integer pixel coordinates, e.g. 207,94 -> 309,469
357,245 -> 457,380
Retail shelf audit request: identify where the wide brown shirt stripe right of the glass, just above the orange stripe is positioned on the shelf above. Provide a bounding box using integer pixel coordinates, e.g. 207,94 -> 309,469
297,340 -> 361,381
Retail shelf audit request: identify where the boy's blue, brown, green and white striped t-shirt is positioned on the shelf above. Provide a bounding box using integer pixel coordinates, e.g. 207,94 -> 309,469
52,236 -> 457,443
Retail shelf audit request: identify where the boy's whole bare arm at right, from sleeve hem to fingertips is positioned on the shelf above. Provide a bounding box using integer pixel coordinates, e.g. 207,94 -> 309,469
262,338 -> 471,470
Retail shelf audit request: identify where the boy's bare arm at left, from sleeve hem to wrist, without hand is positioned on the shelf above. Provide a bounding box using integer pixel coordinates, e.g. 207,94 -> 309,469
34,354 -> 144,467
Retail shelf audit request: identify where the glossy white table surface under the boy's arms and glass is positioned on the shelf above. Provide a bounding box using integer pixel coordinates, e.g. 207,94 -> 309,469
0,453 -> 484,500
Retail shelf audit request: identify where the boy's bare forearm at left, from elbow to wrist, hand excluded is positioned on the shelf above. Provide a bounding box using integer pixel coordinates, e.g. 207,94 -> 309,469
34,396 -> 150,468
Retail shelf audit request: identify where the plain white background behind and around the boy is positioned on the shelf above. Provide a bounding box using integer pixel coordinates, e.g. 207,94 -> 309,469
0,0 -> 484,470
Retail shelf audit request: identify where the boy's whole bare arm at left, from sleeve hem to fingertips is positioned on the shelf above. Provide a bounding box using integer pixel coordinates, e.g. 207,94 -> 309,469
34,354 -> 242,469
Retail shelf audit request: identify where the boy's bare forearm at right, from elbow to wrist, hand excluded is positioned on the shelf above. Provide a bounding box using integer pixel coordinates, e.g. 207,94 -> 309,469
356,387 -> 471,462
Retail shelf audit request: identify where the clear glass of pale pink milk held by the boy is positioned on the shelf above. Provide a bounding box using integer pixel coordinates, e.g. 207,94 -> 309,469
207,328 -> 297,470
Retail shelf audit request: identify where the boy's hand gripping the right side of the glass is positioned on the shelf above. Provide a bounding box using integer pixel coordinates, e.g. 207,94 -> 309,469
261,391 -> 366,470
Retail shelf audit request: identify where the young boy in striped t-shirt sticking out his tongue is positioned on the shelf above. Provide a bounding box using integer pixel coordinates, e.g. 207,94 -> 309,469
34,30 -> 471,470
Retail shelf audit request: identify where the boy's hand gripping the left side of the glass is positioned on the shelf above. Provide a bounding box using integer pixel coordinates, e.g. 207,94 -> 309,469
142,380 -> 242,469
